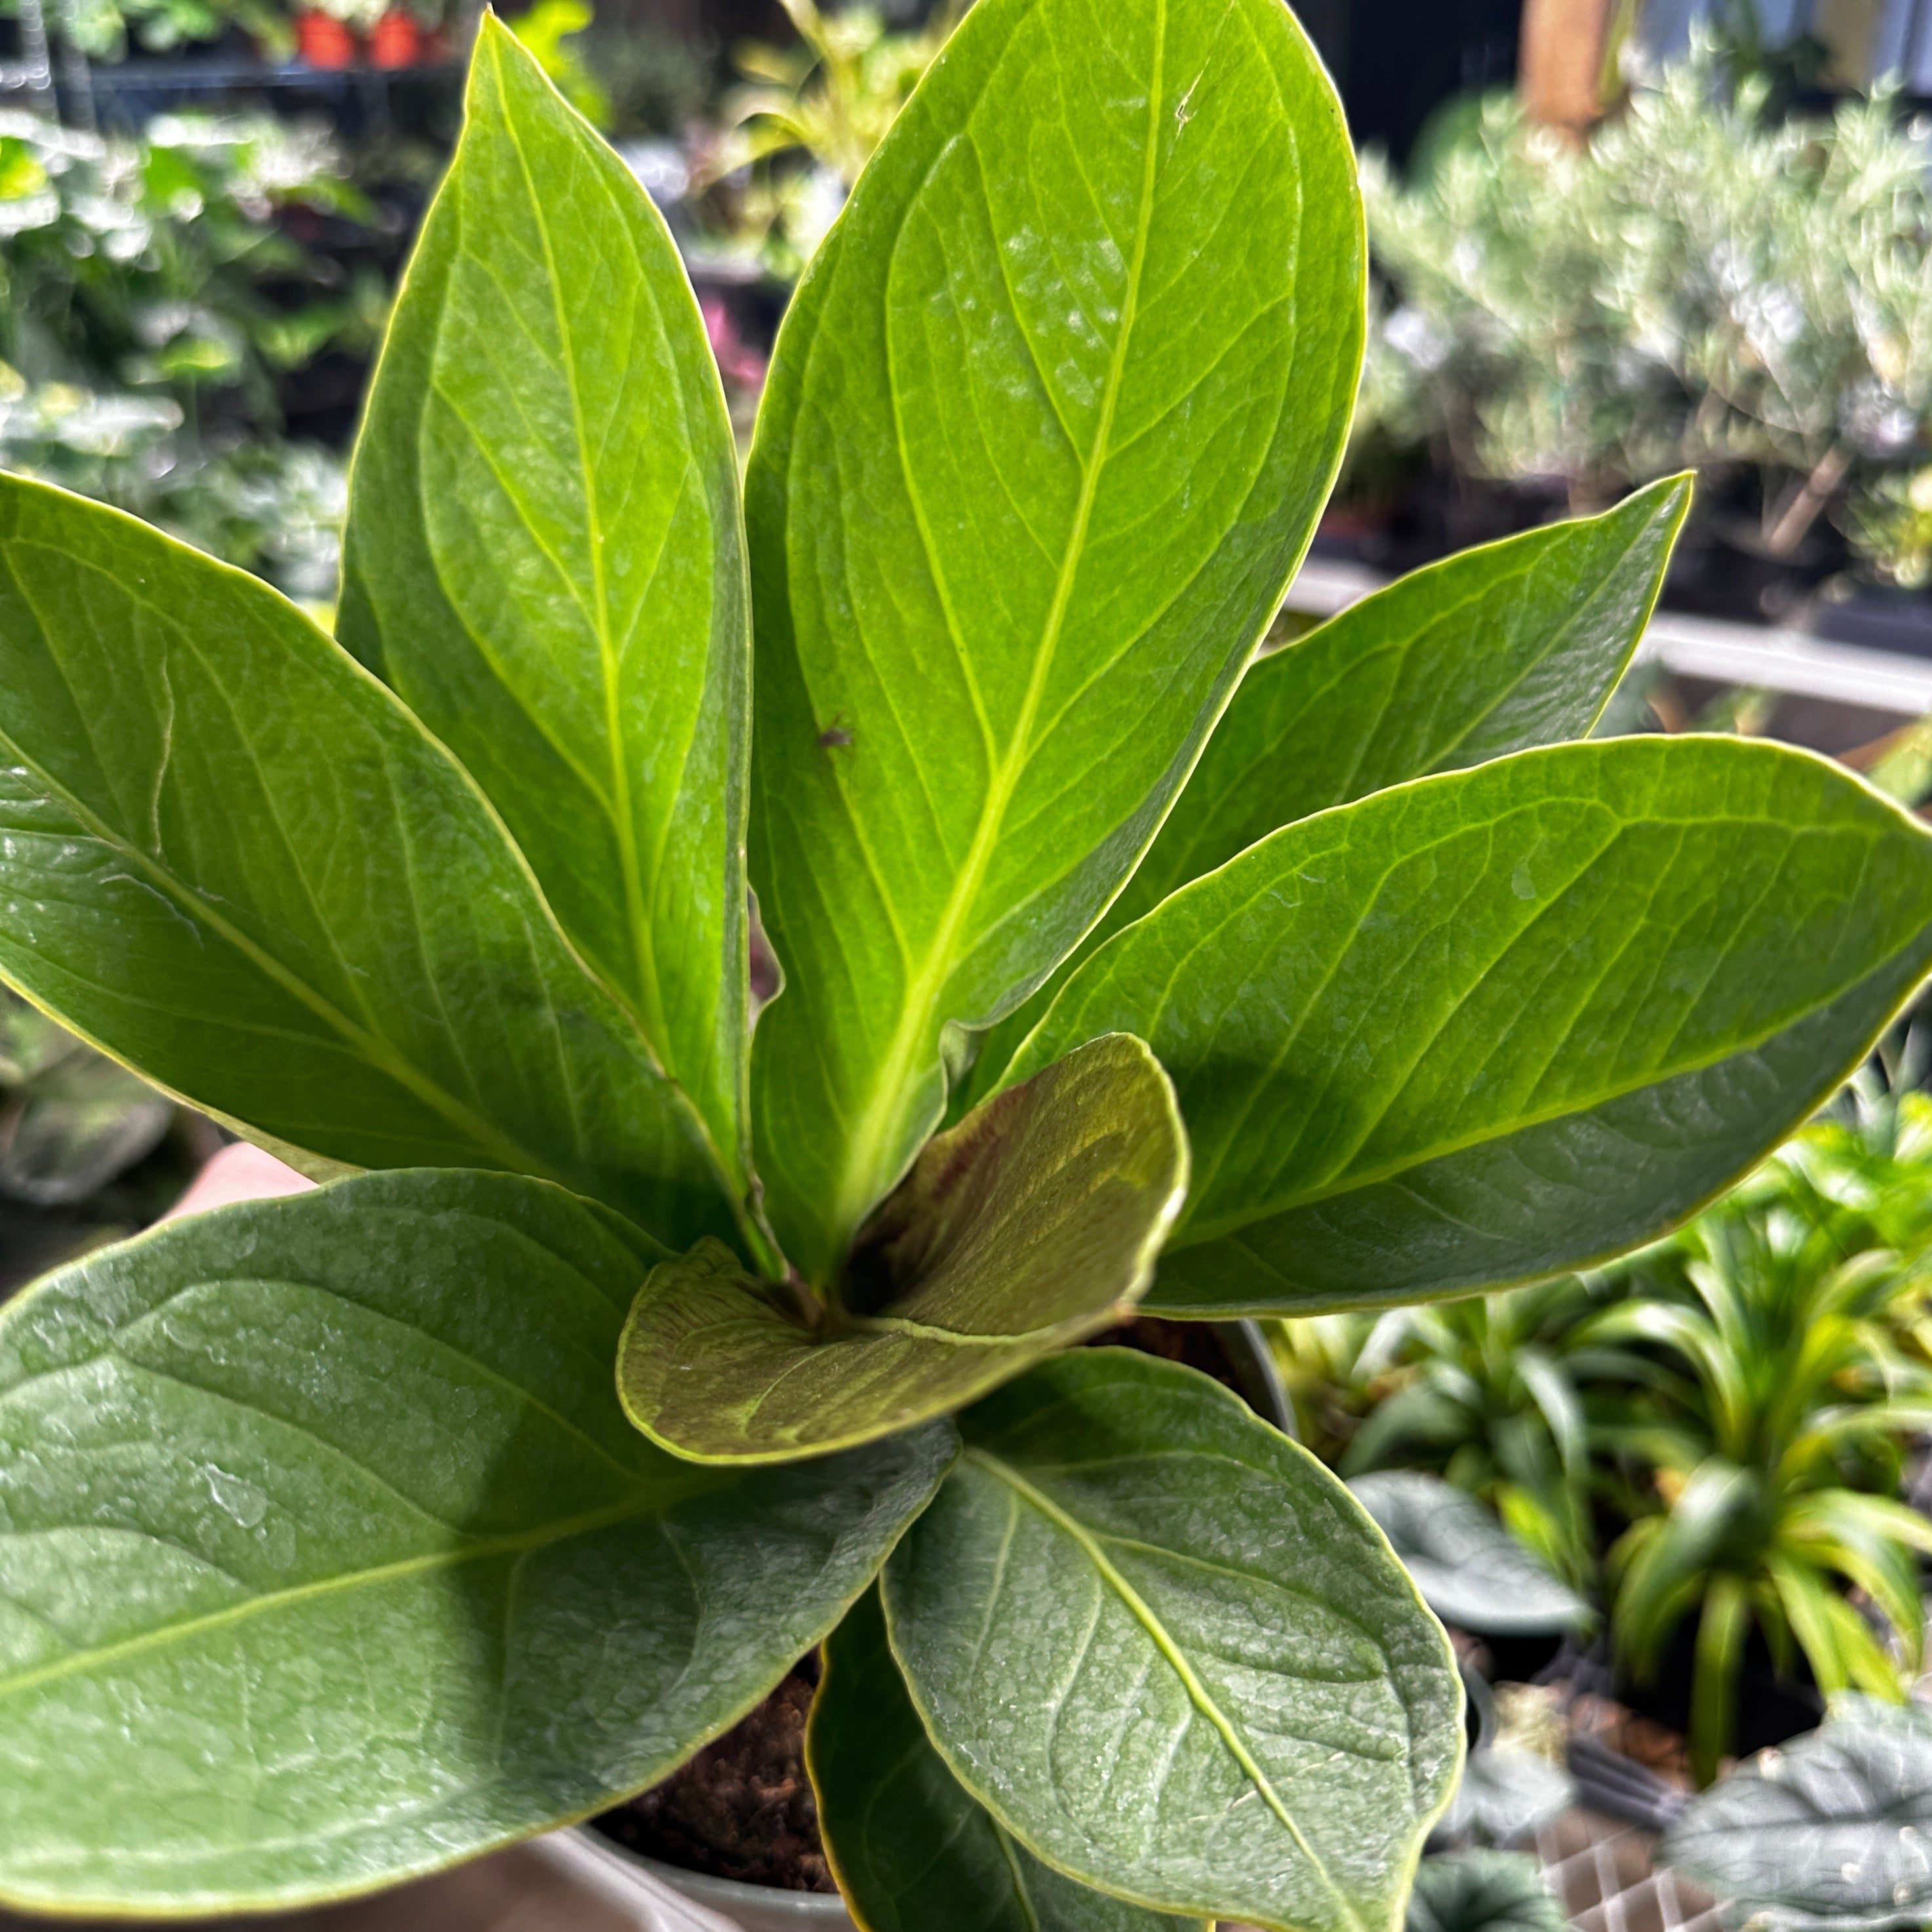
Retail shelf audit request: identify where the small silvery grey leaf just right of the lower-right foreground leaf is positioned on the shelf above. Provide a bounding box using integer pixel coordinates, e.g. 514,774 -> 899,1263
1349,1469 -> 1590,1636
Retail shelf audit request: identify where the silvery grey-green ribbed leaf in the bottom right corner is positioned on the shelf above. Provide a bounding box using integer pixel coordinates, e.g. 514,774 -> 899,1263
1658,1696 -> 1932,1932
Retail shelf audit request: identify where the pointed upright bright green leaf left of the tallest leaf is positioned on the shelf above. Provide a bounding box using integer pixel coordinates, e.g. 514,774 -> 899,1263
340,18 -> 751,1198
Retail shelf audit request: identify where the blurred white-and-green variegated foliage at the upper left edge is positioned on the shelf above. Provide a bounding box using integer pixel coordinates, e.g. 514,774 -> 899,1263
0,114 -> 388,606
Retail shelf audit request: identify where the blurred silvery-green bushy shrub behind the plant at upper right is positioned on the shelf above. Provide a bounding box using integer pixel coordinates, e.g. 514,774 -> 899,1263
1352,39 -> 1932,599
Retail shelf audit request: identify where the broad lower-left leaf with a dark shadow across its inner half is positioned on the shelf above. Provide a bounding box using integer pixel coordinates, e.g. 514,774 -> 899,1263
0,1171 -> 956,1913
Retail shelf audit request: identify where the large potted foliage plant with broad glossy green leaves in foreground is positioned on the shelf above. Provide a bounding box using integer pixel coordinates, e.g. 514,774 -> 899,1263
0,0 -> 1932,1932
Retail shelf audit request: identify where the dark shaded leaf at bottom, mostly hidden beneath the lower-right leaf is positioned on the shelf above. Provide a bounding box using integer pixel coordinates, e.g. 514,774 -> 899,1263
806,1592 -> 1212,1932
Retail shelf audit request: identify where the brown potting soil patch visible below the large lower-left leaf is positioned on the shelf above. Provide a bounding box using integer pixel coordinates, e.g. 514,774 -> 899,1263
597,1658 -> 838,1891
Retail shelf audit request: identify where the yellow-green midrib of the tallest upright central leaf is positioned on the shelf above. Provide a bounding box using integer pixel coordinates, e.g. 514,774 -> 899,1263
829,0 -> 1167,1267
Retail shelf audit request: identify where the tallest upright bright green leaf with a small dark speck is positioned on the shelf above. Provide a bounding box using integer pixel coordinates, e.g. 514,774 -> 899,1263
746,0 -> 1364,1281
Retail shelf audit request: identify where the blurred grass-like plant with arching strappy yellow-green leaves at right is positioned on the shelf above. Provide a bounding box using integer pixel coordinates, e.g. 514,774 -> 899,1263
1579,1135 -> 1932,1783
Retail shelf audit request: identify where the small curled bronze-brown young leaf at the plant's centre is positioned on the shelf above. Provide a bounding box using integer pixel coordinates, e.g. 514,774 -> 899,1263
618,1034 -> 1188,1463
